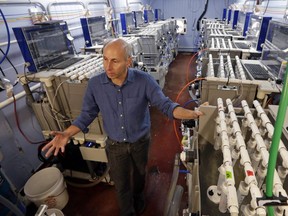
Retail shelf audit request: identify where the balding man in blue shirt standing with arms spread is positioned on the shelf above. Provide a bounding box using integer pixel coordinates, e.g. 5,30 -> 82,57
43,39 -> 202,216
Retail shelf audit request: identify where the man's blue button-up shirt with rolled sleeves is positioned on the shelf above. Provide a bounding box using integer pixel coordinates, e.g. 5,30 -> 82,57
73,68 -> 179,142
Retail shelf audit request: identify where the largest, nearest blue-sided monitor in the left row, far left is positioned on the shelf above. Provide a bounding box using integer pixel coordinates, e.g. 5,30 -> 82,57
13,22 -> 74,72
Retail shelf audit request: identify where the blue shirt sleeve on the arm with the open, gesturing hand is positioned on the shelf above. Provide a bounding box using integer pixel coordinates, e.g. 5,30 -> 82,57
72,80 -> 99,132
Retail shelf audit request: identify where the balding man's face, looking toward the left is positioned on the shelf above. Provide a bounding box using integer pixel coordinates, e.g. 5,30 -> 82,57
103,42 -> 131,81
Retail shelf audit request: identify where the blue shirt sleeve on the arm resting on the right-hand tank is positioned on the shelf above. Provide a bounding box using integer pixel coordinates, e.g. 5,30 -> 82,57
146,75 -> 180,119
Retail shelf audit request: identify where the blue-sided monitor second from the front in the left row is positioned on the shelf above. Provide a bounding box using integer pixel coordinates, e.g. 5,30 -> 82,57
80,16 -> 110,47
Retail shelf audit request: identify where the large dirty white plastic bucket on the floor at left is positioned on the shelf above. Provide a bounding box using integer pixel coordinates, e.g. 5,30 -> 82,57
24,167 -> 69,209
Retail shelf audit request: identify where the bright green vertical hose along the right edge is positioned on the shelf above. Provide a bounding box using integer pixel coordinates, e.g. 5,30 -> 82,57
266,67 -> 288,216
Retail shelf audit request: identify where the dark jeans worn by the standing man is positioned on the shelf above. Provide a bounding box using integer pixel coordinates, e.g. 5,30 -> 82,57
106,134 -> 150,216
